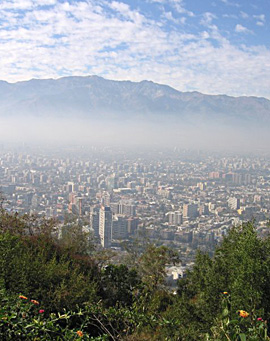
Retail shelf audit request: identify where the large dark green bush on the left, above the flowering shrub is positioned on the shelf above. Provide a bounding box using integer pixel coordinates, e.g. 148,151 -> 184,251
0,213 -> 99,311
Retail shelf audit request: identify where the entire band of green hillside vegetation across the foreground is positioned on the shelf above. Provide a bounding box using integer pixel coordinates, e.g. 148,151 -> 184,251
0,210 -> 270,341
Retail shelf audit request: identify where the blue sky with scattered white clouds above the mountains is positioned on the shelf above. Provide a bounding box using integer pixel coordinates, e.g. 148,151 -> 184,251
0,0 -> 270,99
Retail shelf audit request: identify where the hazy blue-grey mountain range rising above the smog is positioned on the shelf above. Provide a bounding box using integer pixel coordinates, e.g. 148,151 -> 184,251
0,76 -> 270,123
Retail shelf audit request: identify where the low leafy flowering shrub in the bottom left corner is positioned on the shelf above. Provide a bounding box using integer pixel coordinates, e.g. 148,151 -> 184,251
0,291 -> 109,341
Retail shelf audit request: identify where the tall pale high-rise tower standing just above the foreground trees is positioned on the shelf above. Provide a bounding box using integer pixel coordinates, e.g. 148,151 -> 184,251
99,206 -> 112,248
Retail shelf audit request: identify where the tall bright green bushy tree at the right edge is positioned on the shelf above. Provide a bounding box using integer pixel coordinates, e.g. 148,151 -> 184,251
179,223 -> 270,326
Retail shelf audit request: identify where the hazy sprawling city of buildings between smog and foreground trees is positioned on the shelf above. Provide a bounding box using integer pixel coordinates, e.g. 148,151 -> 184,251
0,143 -> 270,268
